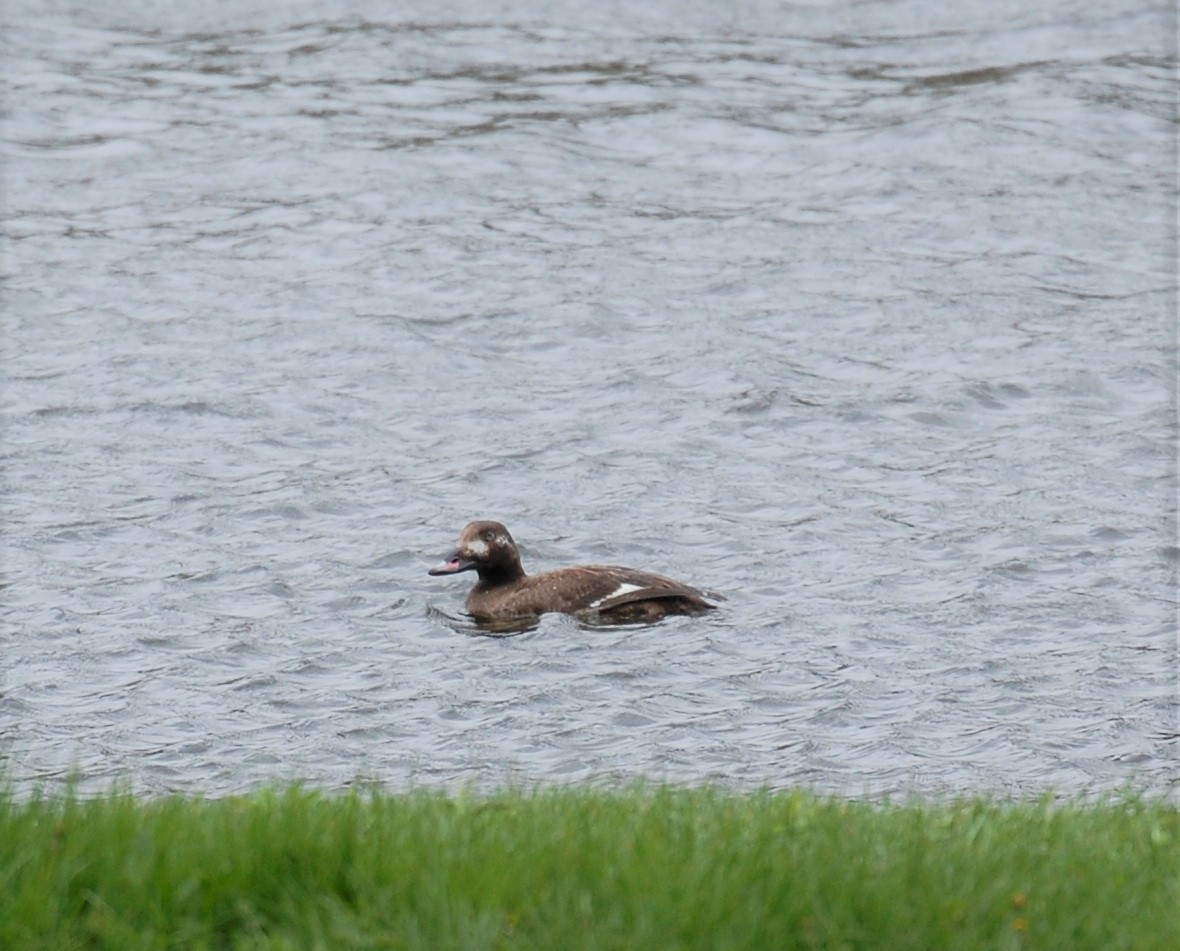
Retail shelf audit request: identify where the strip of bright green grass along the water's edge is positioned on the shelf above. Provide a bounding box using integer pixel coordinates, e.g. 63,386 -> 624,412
0,788 -> 1180,951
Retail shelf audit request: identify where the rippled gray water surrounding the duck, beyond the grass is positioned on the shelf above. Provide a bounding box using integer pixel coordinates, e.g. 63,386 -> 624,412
0,0 -> 1180,795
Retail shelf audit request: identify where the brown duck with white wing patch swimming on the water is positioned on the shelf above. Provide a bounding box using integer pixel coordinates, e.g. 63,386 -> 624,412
427,520 -> 725,623
